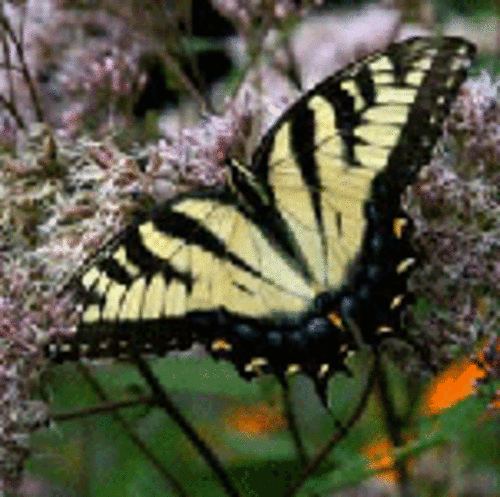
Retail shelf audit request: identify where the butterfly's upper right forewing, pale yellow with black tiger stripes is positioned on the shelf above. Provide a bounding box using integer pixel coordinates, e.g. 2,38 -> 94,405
256,38 -> 472,289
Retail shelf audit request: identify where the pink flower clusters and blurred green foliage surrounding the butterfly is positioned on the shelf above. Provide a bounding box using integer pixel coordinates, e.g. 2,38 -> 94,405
0,0 -> 500,497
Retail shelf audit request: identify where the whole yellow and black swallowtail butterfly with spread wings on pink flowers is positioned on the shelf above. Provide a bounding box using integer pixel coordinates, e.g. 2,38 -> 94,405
51,38 -> 474,404
